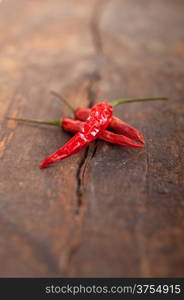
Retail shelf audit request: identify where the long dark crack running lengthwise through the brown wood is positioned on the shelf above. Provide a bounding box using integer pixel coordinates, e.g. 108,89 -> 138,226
65,0 -> 107,276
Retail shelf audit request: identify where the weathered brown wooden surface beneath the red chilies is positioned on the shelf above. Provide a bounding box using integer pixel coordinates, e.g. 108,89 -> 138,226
0,0 -> 184,277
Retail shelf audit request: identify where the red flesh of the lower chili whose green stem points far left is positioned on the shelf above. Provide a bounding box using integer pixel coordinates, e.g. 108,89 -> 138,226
61,118 -> 143,148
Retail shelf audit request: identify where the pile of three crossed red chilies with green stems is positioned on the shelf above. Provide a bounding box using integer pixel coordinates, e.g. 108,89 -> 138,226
8,93 -> 167,168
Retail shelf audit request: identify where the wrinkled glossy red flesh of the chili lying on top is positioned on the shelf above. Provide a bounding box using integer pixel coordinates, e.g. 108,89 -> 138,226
40,102 -> 112,168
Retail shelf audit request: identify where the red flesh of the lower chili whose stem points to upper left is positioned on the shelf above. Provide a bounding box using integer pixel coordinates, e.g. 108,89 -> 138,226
75,108 -> 144,144
